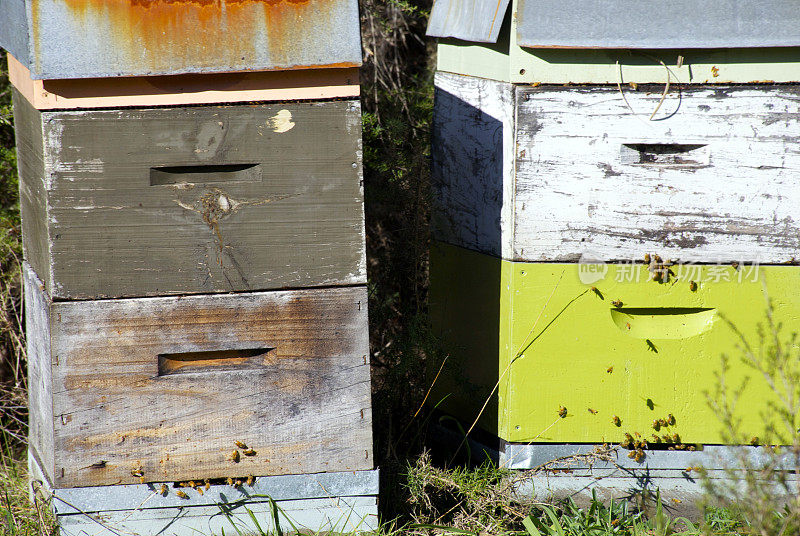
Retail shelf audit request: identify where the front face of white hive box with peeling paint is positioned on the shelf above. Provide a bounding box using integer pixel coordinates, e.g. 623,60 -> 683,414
513,86 -> 800,263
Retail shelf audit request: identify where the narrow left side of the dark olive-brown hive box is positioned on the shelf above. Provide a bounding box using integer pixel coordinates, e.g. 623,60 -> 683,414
11,92 -> 51,294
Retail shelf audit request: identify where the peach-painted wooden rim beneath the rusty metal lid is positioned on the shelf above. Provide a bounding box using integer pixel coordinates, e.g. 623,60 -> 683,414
8,54 -> 360,110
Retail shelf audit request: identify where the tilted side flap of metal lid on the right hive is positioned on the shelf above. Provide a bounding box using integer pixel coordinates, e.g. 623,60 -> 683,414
427,0 -> 509,43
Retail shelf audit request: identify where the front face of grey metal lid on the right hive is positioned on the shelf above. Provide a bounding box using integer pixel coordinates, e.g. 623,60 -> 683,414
517,0 -> 800,49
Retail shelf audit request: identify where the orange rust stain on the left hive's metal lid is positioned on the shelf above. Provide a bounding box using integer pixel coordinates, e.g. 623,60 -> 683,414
43,0 -> 344,70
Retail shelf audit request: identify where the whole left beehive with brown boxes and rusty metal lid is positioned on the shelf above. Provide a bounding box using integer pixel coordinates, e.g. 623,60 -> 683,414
0,0 -> 377,535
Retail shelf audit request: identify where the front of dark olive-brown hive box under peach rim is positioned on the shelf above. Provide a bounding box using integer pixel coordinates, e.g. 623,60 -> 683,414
23,101 -> 366,299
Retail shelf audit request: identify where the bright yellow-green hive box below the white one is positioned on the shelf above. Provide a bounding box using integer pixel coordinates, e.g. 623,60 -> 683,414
431,242 -> 800,444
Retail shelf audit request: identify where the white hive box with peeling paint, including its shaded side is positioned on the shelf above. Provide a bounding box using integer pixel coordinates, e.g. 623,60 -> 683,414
432,73 -> 800,264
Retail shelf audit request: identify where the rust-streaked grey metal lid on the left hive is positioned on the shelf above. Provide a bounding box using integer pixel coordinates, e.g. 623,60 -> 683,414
0,0 -> 361,79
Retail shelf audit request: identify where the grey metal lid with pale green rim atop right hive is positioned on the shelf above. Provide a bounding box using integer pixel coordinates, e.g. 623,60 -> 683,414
428,0 -> 800,84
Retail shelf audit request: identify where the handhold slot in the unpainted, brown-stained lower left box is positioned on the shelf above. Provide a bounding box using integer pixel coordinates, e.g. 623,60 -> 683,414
158,348 -> 274,376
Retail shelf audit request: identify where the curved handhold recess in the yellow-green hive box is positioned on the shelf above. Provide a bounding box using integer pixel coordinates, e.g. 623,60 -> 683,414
611,307 -> 716,339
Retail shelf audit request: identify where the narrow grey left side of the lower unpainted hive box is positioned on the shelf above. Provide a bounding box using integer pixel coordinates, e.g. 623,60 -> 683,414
23,265 -> 55,482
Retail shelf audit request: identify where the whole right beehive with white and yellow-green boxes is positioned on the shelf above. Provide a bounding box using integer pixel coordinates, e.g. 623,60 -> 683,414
429,0 -> 800,506
